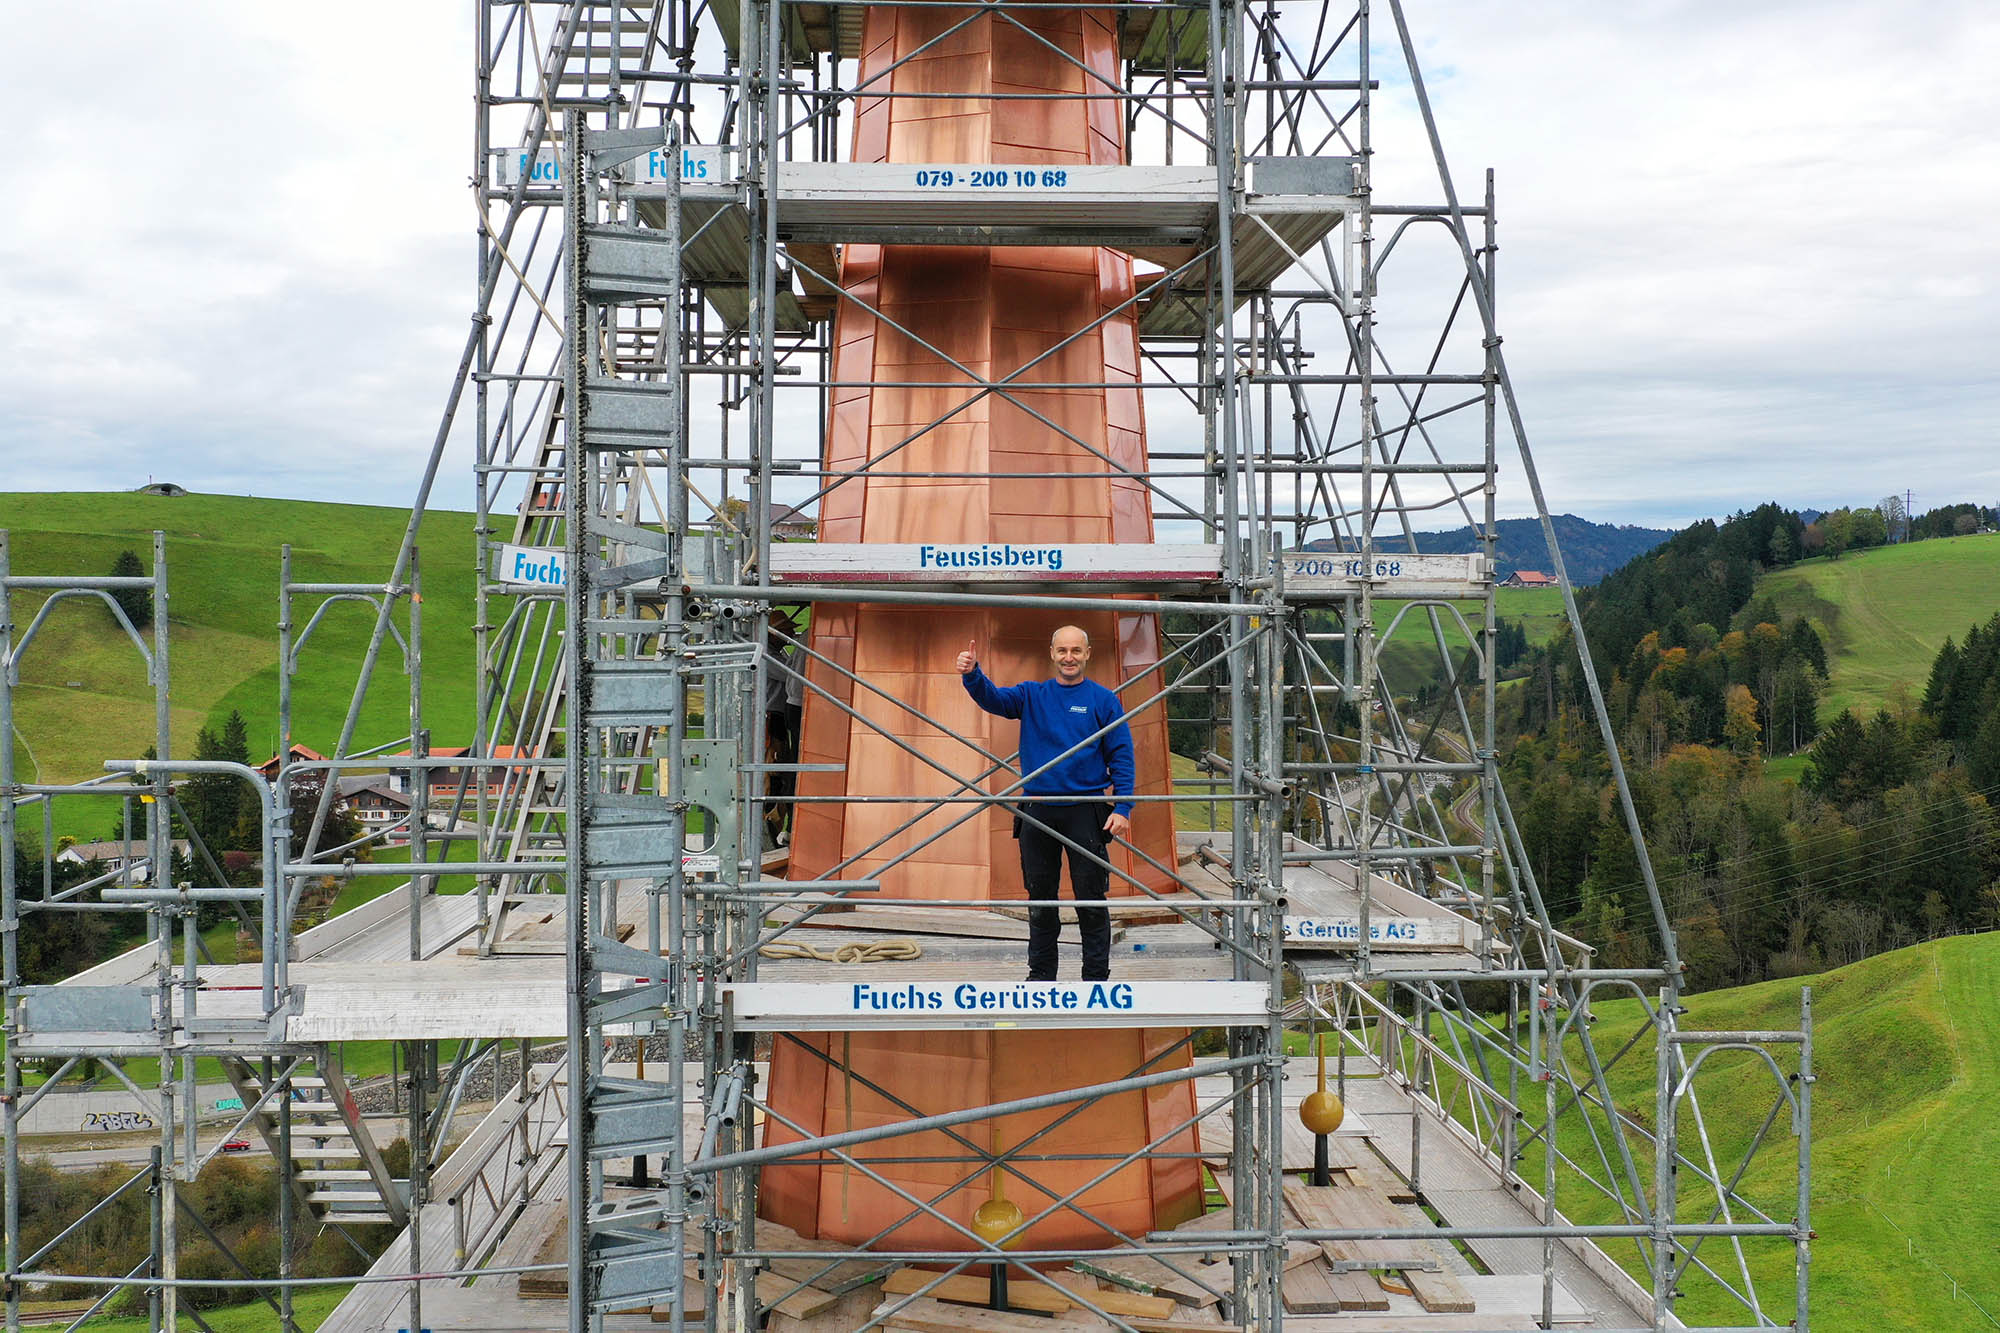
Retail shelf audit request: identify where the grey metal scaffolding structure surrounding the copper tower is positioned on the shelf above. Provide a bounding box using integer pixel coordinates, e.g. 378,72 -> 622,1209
0,0 -> 1812,1333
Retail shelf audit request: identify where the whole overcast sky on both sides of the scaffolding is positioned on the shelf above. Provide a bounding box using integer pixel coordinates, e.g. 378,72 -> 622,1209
0,0 -> 2000,524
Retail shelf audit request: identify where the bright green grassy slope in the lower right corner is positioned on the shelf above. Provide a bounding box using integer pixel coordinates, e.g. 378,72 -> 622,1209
1560,933 -> 2000,1333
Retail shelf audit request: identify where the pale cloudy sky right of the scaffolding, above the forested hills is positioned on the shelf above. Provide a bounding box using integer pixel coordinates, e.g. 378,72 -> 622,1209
1378,2 -> 2000,522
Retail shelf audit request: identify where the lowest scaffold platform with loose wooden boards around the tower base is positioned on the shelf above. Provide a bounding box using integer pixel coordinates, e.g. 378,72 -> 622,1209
322,1057 -> 1646,1333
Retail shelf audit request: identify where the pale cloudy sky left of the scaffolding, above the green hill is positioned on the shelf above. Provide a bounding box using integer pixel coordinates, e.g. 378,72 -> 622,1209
0,2 -> 476,500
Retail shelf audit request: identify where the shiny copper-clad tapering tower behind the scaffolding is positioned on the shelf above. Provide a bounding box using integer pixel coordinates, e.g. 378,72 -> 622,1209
760,8 -> 1200,1249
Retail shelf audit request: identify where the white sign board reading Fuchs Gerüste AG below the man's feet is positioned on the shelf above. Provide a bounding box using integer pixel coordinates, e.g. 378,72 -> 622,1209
728,981 -> 1270,1029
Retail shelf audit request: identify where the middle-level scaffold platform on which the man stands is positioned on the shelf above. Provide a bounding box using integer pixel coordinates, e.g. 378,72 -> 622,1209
20,833 -> 1504,1055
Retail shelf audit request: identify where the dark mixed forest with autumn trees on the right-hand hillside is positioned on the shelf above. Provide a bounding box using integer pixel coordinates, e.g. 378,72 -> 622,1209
1502,504 -> 2000,987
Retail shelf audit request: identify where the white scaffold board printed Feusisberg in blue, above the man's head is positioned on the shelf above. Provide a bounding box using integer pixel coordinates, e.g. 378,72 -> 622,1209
770,542 -> 1222,584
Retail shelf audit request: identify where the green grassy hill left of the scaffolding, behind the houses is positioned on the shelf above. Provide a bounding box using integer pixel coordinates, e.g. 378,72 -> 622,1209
0,492 -> 474,837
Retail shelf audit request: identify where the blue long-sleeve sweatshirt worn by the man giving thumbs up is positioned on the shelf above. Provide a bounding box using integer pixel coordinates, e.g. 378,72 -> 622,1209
960,667 -> 1132,817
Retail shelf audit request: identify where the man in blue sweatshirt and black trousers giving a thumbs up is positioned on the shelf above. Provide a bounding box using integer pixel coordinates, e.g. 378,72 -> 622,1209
958,624 -> 1132,981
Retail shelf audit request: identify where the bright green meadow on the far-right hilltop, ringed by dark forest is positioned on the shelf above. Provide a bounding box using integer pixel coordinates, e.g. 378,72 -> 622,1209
1758,534 -> 2000,717
